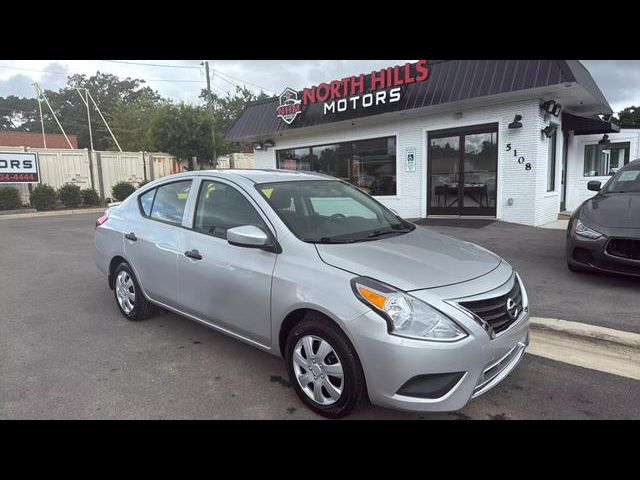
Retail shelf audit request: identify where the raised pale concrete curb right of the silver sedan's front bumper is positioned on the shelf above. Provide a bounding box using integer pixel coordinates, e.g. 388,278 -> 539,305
529,317 -> 640,350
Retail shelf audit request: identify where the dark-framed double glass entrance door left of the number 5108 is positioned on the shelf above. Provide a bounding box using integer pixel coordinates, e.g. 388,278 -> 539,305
427,124 -> 498,216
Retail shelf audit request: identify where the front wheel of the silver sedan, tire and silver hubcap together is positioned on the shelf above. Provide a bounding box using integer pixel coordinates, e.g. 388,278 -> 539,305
285,313 -> 365,418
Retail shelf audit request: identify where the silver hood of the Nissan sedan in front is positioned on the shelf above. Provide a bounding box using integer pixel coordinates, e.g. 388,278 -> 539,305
316,227 -> 501,291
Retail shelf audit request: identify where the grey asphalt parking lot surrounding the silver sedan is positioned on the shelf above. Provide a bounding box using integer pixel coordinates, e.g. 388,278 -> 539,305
0,214 -> 640,419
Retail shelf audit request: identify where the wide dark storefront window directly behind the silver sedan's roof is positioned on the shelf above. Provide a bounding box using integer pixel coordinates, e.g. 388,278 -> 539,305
276,137 -> 397,196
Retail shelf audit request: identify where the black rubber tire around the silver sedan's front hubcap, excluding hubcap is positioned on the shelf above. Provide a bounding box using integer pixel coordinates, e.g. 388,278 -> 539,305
285,313 -> 366,418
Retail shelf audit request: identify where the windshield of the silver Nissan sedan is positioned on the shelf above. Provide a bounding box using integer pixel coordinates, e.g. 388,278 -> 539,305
256,180 -> 415,243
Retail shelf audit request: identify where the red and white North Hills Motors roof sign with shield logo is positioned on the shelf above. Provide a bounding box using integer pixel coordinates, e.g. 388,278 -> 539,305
276,60 -> 429,125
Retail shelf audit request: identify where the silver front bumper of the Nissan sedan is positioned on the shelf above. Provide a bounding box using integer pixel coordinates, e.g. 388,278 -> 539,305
350,309 -> 529,411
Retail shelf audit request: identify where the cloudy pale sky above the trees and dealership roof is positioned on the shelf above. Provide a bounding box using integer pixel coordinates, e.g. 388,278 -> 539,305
0,60 -> 640,112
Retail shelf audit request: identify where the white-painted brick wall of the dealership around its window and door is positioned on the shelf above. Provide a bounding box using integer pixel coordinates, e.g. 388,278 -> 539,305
255,99 -> 562,225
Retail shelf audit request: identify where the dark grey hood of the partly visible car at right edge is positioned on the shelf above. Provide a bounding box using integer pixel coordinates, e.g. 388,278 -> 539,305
581,193 -> 640,228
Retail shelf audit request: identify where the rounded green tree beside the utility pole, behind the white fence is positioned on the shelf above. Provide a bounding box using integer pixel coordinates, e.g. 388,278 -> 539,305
147,103 -> 213,164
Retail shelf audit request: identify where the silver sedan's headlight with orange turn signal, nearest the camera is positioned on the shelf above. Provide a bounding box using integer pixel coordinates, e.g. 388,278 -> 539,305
351,277 -> 467,342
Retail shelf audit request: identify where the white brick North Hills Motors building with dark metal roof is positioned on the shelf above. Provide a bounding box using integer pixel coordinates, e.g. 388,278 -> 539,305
226,60 -> 640,226
